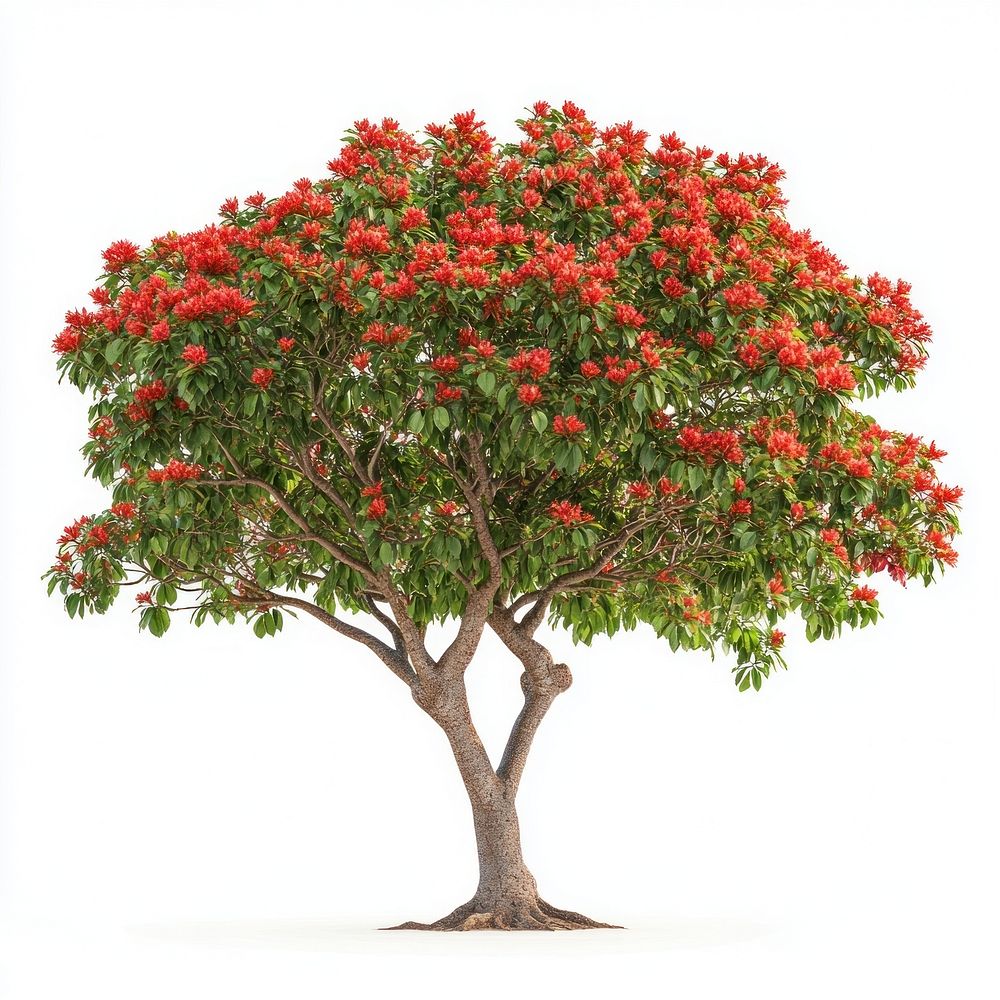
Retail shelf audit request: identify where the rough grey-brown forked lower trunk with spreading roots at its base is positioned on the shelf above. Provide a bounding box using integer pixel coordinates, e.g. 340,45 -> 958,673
390,664 -> 616,931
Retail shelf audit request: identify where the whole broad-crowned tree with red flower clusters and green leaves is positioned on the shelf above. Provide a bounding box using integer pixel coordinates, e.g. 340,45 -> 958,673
48,103 -> 961,929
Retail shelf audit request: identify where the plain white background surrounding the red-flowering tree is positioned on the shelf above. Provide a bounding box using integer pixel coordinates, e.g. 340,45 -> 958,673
0,0 -> 1000,1000
